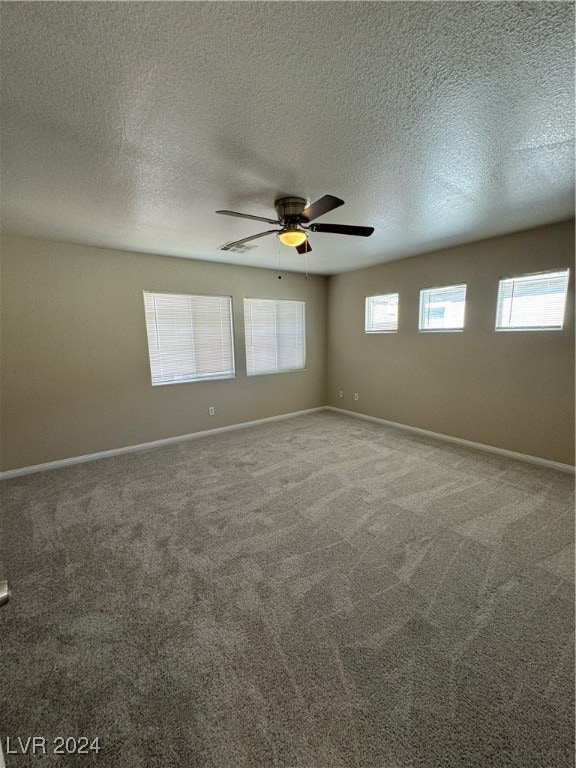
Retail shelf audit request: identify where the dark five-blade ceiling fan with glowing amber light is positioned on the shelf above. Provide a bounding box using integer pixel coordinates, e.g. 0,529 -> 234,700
216,195 -> 374,253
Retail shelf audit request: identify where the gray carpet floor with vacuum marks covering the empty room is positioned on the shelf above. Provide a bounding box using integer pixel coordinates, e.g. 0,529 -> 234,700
0,412 -> 574,768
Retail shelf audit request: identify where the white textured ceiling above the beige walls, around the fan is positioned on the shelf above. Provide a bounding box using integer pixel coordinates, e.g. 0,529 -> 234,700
1,2 -> 574,274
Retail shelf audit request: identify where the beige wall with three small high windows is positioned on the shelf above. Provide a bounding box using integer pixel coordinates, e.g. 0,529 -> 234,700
328,221 -> 574,464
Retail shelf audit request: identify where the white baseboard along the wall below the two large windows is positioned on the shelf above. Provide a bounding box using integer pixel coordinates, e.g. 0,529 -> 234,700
0,405 -> 326,480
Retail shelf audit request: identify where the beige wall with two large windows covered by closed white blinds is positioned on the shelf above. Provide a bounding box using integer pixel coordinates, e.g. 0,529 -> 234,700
0,237 -> 327,470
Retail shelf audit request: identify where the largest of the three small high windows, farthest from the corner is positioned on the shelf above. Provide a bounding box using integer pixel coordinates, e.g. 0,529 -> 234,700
496,269 -> 569,331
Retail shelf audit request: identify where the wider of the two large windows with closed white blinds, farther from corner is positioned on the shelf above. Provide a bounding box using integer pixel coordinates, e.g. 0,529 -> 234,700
144,291 -> 234,385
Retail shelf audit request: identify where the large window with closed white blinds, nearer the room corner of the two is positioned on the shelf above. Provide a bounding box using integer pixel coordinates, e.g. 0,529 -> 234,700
244,299 -> 306,376
